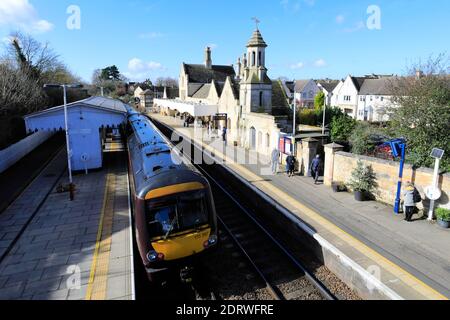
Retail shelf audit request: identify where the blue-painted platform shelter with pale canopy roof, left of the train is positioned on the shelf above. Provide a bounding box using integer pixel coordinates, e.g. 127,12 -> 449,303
24,97 -> 127,171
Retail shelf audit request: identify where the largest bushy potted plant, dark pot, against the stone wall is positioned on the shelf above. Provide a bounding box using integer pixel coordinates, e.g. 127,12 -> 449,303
348,160 -> 377,201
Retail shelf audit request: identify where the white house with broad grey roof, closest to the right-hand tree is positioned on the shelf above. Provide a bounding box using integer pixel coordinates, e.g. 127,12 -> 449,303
356,77 -> 395,122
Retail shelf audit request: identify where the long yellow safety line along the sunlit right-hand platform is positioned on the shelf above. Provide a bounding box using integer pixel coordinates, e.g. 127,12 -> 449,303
167,119 -> 448,300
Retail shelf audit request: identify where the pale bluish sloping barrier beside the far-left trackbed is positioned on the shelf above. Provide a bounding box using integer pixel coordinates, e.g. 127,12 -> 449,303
0,131 -> 54,173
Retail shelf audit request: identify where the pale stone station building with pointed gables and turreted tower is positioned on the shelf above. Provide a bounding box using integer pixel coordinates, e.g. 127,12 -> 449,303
163,29 -> 292,154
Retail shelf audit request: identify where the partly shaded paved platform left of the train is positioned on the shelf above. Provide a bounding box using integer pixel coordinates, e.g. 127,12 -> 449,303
0,150 -> 135,300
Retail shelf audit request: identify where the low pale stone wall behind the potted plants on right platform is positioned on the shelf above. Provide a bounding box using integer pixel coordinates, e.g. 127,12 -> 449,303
325,151 -> 450,209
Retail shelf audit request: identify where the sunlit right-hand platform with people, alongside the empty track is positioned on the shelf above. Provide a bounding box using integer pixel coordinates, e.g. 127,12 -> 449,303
150,114 -> 450,300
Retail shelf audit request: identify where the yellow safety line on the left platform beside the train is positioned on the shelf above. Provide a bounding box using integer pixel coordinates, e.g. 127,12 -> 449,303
85,173 -> 116,300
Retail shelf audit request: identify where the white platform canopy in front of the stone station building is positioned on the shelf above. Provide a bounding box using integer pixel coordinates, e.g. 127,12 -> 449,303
154,99 -> 219,117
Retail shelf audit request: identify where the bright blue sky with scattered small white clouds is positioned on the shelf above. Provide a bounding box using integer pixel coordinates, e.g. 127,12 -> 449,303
0,0 -> 450,81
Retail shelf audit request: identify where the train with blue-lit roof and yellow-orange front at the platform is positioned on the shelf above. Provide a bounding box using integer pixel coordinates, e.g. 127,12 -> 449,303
125,107 -> 218,282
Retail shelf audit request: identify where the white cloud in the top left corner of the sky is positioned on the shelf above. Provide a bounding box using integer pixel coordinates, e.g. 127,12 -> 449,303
0,0 -> 53,33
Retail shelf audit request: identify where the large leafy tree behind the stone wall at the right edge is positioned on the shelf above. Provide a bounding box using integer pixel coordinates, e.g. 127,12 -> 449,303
389,54 -> 450,171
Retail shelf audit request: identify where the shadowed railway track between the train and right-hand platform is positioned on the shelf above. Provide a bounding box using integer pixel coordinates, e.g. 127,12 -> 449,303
153,119 -> 336,300
